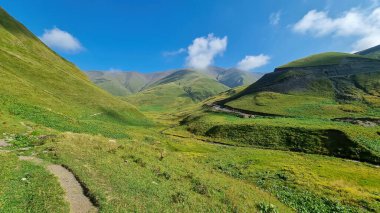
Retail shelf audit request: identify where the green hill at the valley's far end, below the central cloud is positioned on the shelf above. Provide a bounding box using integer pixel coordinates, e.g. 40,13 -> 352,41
126,70 -> 229,111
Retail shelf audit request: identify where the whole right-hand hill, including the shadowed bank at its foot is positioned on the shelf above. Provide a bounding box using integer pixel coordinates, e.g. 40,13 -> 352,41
181,50 -> 380,164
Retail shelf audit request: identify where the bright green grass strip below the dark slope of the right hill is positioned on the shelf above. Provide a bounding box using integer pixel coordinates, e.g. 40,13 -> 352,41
226,92 -> 380,118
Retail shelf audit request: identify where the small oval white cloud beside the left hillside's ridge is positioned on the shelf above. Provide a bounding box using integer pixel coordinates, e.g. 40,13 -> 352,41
40,27 -> 84,53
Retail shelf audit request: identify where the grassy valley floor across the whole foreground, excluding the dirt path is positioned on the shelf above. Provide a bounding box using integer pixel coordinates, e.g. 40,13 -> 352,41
0,108 -> 380,212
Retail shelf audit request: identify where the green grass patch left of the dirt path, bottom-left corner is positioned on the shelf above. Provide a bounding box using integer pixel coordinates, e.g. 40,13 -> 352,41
0,152 -> 69,213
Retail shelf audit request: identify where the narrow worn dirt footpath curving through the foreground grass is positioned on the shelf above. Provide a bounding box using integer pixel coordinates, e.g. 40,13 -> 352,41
20,156 -> 98,213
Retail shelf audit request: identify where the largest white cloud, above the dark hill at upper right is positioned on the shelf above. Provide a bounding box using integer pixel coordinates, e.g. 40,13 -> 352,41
293,7 -> 380,51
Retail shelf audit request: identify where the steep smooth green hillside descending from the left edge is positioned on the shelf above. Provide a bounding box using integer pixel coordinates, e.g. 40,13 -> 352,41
0,8 -> 149,138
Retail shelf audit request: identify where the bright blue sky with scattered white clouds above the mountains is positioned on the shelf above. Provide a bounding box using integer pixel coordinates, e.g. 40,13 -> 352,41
0,0 -> 380,73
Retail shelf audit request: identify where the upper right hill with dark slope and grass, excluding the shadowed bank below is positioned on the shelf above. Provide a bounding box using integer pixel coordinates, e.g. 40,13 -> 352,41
222,53 -> 380,117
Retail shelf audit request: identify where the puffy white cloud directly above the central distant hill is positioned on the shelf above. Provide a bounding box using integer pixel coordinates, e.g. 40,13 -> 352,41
186,34 -> 227,69
